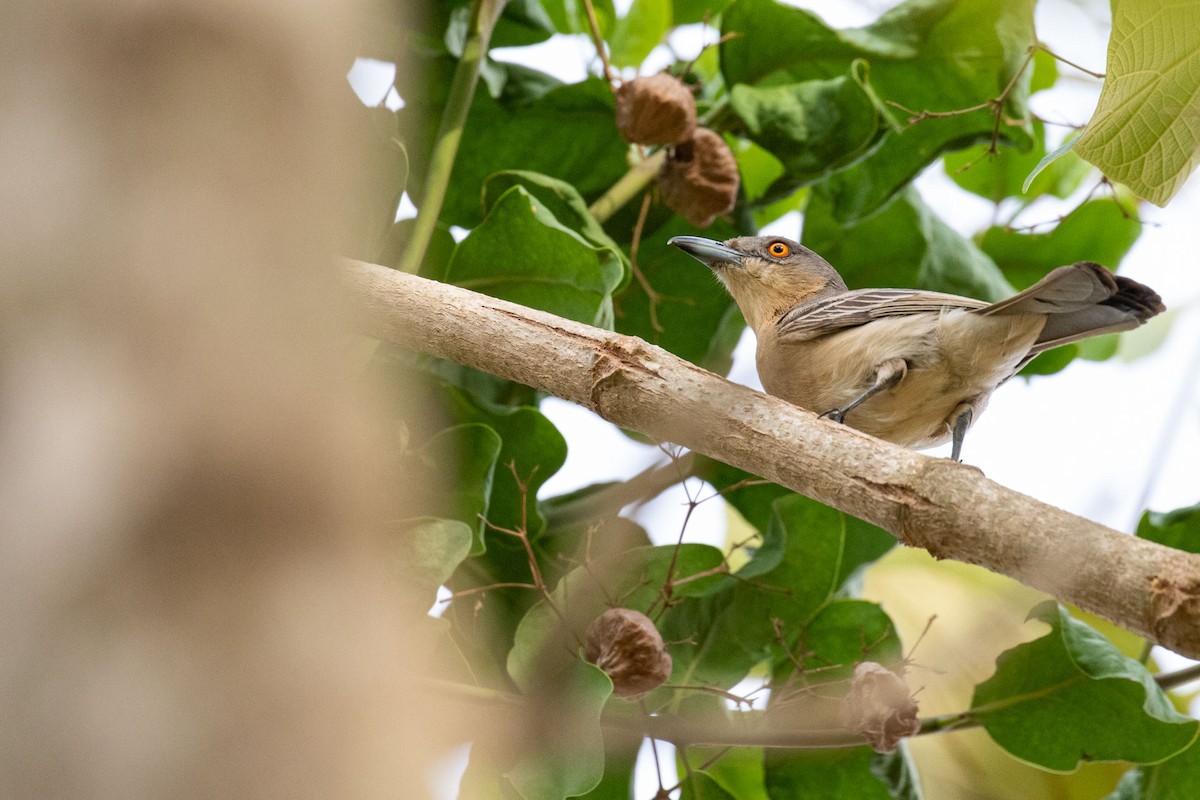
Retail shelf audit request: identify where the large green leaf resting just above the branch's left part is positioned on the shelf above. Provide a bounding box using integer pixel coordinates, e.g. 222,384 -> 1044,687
444,186 -> 625,327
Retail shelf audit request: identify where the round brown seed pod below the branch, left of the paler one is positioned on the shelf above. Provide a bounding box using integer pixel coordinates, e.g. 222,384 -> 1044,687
586,608 -> 671,697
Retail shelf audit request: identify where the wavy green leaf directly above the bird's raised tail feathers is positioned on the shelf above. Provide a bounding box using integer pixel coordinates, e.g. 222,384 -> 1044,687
979,199 -> 1141,289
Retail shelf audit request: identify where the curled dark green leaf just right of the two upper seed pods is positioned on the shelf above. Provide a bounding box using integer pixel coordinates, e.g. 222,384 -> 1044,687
730,74 -> 881,197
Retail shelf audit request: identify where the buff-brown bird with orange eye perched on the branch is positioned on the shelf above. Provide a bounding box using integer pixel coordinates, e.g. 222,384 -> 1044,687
667,236 -> 1165,461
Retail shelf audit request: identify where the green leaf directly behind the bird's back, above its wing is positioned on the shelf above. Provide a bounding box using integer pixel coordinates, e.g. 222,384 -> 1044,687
803,187 -> 1012,300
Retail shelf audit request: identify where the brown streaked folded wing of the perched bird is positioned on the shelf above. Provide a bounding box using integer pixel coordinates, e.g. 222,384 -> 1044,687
778,289 -> 988,339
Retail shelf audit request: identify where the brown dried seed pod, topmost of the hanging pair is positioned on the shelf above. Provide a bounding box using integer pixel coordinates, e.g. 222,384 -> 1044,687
617,72 -> 696,144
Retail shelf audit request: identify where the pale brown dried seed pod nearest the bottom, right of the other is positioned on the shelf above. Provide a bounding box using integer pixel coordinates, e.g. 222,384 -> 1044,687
841,661 -> 920,753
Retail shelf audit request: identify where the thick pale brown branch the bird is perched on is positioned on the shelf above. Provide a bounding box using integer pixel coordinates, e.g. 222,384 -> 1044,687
347,261 -> 1200,657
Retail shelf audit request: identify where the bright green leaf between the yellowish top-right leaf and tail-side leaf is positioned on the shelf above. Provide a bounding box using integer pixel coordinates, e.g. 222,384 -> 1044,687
942,120 -> 1091,203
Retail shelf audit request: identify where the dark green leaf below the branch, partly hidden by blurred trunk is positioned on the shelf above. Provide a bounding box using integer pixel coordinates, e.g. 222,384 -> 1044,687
400,423 -> 502,554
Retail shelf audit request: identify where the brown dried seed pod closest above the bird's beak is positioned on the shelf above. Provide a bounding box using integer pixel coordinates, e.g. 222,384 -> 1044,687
659,128 -> 738,228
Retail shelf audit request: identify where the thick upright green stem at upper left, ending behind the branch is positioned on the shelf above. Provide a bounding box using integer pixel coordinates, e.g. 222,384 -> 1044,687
398,0 -> 509,275
